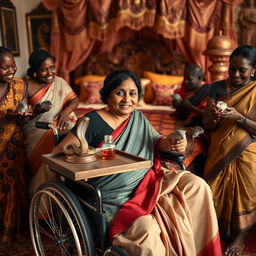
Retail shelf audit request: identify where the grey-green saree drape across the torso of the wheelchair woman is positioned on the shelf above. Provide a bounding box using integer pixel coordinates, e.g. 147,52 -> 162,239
91,111 -> 160,222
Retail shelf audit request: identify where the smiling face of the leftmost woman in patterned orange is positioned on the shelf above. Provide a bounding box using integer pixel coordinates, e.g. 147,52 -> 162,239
0,53 -> 17,83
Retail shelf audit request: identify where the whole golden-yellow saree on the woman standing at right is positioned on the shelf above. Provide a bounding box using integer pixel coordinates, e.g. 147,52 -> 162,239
204,81 -> 256,236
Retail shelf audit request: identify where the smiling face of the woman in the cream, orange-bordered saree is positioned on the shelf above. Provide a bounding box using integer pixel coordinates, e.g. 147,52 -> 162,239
35,58 -> 56,84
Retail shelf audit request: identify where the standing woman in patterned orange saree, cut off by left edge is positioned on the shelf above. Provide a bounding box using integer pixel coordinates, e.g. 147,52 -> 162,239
0,46 -> 28,242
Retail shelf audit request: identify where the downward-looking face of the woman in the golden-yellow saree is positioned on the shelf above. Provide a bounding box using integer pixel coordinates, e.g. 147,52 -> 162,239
228,56 -> 255,86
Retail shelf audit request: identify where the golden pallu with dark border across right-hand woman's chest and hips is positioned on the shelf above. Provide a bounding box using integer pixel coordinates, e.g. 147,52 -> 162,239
204,81 -> 256,181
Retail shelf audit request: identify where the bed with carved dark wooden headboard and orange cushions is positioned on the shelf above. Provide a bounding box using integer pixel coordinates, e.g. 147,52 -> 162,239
72,41 -> 204,169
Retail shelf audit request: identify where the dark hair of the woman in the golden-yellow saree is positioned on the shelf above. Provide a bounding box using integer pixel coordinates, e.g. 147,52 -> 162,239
229,45 -> 256,68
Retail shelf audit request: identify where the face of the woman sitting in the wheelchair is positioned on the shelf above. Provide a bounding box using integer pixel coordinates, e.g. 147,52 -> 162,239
108,78 -> 139,116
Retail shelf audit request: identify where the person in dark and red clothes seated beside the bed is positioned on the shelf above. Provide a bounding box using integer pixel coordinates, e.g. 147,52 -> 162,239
173,64 -> 210,125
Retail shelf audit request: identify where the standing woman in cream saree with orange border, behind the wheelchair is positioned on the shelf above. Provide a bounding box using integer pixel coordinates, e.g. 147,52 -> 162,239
24,49 -> 79,193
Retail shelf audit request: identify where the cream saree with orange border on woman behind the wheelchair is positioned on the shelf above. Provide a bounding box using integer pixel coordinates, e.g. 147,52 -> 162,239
24,76 -> 77,175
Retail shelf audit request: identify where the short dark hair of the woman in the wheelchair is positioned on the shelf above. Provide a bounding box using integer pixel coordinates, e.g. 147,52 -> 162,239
100,70 -> 142,103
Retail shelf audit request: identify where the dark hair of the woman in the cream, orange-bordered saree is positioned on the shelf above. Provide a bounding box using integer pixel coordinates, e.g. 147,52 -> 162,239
27,49 -> 56,78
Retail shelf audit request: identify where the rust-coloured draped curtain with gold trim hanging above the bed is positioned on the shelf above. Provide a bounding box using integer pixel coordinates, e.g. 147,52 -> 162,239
44,0 -> 242,81
